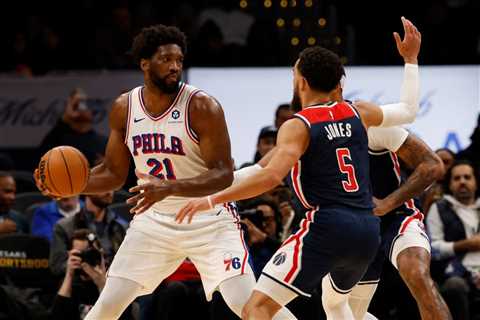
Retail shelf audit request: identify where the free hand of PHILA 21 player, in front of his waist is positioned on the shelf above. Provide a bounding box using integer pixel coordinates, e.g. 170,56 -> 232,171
127,170 -> 172,214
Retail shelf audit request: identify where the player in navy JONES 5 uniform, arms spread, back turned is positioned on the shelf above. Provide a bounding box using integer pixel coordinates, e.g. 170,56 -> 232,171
175,18 -> 421,320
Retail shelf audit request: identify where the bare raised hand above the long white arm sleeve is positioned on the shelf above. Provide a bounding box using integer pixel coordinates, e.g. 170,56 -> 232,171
393,17 -> 422,64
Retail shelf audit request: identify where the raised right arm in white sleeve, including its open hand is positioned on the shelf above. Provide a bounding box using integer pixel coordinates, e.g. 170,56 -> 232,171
355,17 -> 421,128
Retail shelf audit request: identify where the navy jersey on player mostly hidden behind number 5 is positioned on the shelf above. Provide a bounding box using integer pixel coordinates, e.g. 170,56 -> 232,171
369,150 -> 423,224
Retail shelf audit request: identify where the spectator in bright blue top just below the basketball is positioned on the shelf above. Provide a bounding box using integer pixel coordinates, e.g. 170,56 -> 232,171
31,196 -> 83,242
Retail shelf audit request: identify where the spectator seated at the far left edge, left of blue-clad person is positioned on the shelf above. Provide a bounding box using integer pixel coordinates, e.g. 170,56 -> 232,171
0,171 -> 29,235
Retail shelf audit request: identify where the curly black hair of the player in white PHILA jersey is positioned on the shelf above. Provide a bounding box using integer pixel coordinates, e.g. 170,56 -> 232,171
131,24 -> 187,64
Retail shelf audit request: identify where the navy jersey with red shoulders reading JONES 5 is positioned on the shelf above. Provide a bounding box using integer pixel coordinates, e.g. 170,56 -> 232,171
290,102 -> 372,209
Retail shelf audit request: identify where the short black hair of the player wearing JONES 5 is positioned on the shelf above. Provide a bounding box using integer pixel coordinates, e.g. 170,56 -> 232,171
297,46 -> 345,92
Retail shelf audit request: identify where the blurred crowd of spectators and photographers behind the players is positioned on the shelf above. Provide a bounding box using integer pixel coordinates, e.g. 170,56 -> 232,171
0,89 -> 480,320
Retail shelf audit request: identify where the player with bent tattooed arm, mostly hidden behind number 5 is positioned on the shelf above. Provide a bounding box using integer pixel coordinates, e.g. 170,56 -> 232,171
349,127 -> 451,320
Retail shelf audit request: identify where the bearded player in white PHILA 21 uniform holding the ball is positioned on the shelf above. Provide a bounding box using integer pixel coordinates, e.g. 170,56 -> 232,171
34,25 -> 295,319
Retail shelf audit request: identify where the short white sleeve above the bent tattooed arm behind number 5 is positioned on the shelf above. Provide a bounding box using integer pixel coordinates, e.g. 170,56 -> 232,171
367,127 -> 408,152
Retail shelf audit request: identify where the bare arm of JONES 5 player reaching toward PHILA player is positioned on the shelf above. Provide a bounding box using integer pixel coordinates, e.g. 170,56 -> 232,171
176,118 -> 310,223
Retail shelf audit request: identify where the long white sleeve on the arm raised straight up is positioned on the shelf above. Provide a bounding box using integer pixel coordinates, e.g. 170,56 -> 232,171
380,63 -> 420,127
